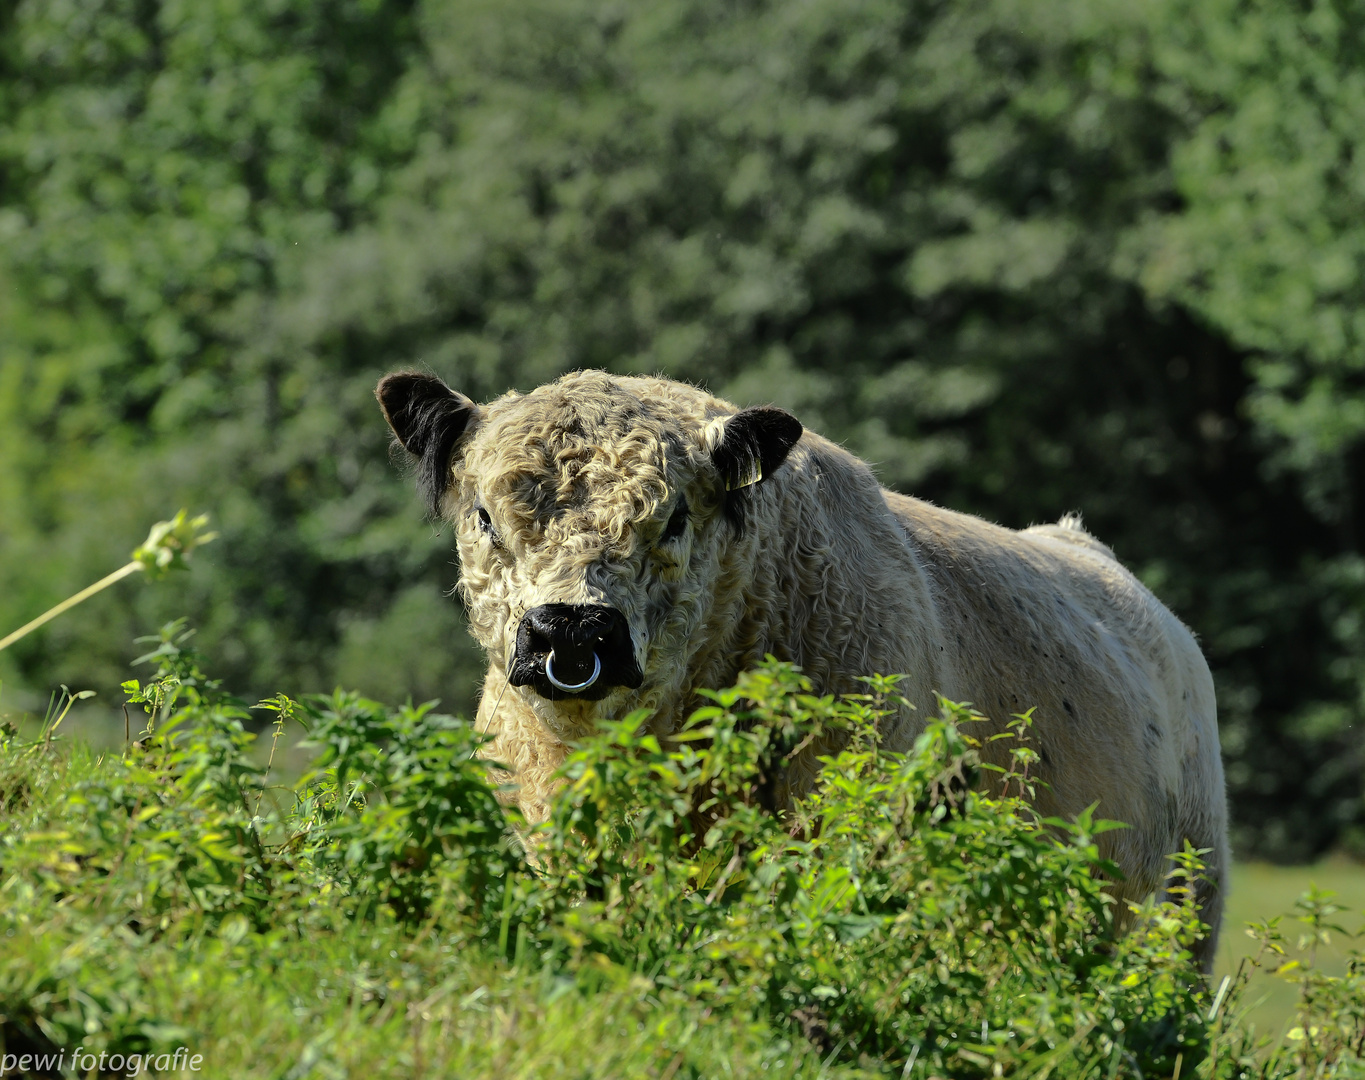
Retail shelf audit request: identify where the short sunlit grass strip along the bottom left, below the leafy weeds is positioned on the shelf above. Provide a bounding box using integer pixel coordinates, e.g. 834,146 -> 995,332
8,916 -> 850,1080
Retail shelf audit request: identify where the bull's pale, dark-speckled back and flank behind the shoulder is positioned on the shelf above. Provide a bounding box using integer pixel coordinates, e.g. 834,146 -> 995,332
886,493 -> 1222,893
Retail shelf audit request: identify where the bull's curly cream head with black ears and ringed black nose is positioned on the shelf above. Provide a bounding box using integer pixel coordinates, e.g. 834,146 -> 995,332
377,371 -> 801,735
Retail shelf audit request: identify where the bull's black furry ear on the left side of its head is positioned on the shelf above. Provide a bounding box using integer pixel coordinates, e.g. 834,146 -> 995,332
374,371 -> 479,516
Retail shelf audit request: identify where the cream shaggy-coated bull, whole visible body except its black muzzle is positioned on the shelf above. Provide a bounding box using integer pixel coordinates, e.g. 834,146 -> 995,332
378,371 -> 1229,967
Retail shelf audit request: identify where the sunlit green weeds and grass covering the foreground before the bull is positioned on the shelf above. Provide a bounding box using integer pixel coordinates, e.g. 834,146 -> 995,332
0,638 -> 1343,1077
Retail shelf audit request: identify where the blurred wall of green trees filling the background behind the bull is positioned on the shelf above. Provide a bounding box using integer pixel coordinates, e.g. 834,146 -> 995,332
0,0 -> 1365,859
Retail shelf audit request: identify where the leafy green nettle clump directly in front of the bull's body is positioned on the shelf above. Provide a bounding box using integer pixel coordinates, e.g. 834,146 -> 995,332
526,665 -> 1204,1075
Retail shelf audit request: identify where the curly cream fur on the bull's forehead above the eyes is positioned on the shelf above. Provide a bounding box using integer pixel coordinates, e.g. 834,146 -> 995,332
452,371 -> 733,557
